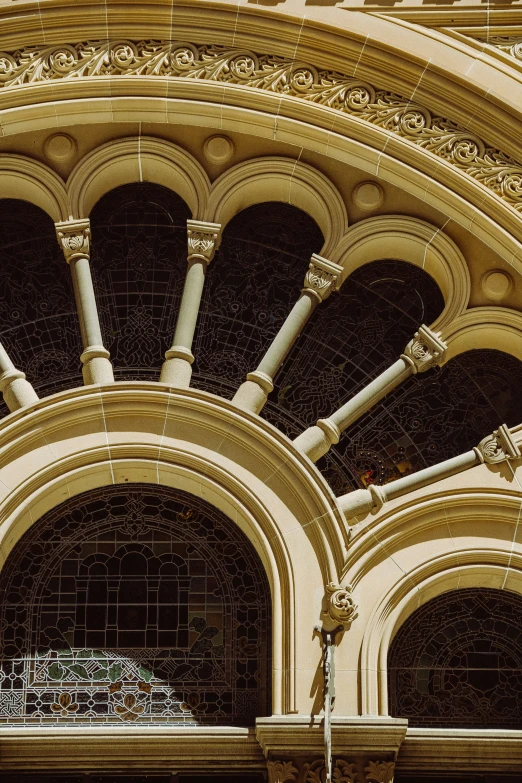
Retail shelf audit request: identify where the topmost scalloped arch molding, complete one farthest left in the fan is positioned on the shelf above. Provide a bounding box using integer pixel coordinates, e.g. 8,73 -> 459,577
67,136 -> 210,220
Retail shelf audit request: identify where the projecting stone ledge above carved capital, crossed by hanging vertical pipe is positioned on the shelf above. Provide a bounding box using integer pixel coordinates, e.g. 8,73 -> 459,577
256,715 -> 408,757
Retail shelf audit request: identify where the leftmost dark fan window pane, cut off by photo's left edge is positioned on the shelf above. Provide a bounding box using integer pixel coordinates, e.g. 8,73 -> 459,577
0,199 -> 83,415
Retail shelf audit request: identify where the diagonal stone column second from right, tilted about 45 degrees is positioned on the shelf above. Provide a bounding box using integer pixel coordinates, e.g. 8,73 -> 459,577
294,325 -> 447,462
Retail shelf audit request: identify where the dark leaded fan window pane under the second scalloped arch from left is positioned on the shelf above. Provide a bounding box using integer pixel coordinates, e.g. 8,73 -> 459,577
91,183 -> 191,381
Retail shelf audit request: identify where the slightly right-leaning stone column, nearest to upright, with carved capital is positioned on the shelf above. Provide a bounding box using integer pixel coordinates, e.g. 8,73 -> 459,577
160,220 -> 221,388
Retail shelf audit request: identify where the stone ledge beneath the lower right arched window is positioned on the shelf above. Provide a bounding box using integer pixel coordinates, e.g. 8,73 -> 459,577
397,728 -> 522,772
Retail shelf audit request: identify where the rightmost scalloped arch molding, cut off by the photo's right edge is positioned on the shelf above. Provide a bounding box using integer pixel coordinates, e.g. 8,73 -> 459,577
444,307 -> 522,361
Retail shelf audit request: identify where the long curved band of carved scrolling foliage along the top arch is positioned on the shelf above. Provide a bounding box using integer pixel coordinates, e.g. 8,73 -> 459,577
0,39 -> 522,211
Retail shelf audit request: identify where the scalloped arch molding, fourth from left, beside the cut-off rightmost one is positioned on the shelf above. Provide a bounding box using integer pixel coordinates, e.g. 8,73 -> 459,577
332,215 -> 471,330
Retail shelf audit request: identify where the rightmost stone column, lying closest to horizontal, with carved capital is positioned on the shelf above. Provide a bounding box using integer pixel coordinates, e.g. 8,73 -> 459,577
338,424 -> 522,519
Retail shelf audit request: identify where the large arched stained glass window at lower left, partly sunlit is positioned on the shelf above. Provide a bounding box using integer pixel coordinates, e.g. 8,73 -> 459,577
0,485 -> 270,725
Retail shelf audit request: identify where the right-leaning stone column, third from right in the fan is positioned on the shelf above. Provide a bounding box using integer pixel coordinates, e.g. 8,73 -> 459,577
232,253 -> 342,413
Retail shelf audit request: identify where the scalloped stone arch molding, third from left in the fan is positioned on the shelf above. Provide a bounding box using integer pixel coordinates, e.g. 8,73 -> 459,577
207,152 -> 348,251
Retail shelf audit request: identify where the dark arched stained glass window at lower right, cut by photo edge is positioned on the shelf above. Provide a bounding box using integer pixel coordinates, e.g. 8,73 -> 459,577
388,588 -> 522,729
